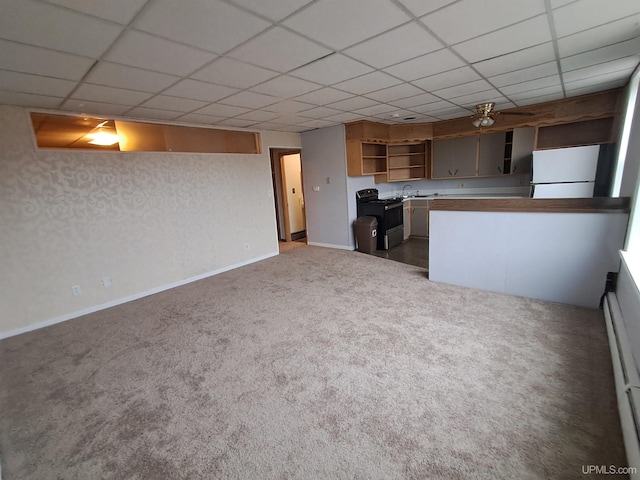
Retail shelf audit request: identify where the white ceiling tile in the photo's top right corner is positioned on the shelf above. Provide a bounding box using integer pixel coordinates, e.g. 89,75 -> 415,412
552,0 -> 640,37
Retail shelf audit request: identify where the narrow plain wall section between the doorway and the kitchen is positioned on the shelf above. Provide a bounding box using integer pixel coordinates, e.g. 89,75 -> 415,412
301,125 -> 352,249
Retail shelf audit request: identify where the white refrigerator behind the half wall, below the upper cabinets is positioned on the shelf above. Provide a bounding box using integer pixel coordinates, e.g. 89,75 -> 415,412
531,145 -> 600,198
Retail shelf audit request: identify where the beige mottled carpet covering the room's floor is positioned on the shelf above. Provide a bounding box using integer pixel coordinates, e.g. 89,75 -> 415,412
0,245 -> 625,480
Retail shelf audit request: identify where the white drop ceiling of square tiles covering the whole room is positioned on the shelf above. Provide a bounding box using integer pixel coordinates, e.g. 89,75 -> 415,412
0,0 -> 640,132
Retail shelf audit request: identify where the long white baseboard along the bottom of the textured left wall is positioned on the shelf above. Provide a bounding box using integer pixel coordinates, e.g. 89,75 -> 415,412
0,252 -> 278,342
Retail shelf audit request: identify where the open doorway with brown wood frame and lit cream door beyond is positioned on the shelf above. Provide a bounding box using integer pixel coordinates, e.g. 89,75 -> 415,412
270,148 -> 307,242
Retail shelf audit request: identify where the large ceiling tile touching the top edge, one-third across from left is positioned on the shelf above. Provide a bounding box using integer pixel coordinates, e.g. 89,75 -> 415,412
136,0 -> 270,53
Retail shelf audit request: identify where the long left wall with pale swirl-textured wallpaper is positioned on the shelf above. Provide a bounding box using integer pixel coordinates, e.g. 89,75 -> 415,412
0,106 -> 299,335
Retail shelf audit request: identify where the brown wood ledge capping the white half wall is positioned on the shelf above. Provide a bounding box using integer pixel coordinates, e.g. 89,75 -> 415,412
430,197 -> 631,213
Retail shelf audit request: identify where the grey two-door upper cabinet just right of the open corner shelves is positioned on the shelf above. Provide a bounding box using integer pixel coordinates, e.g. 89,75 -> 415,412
431,136 -> 478,178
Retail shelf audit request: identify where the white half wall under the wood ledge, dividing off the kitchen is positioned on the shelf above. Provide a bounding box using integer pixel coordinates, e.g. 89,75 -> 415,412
429,210 -> 628,308
